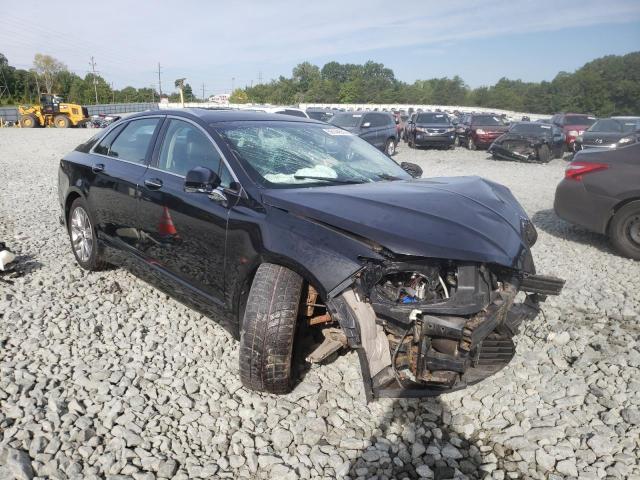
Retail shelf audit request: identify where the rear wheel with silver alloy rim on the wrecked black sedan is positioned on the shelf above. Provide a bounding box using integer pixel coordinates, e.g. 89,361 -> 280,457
67,198 -> 107,271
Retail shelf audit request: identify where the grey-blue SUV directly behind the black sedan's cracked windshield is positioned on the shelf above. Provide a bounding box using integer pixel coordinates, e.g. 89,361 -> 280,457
329,112 -> 398,155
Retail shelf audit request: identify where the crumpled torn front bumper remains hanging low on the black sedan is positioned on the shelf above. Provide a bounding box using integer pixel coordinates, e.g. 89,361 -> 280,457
328,275 -> 564,400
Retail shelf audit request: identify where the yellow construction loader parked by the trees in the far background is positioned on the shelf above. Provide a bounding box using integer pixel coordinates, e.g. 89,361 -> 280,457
18,93 -> 89,128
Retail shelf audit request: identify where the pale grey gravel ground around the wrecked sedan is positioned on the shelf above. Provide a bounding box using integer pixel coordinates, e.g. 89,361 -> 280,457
0,129 -> 640,480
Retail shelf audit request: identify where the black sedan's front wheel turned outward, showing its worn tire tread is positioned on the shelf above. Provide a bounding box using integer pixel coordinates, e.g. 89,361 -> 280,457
239,263 -> 303,393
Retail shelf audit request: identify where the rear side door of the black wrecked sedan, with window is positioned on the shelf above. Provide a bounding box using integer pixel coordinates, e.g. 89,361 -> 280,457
87,116 -> 163,248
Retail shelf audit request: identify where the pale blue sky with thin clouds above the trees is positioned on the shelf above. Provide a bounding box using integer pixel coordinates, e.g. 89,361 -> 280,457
0,0 -> 640,95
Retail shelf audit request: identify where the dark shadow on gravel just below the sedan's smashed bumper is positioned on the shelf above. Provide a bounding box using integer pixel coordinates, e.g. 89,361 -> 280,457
349,397 -> 488,480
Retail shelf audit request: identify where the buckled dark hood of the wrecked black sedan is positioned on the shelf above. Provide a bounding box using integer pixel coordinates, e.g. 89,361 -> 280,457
263,177 -> 527,268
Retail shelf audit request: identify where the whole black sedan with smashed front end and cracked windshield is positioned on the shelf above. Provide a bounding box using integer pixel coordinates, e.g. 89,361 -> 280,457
58,110 -> 563,399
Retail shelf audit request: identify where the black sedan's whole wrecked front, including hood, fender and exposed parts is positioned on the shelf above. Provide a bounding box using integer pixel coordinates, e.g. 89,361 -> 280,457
263,177 -> 564,399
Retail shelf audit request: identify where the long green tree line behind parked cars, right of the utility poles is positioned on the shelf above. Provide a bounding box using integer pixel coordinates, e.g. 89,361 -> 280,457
232,52 -> 640,116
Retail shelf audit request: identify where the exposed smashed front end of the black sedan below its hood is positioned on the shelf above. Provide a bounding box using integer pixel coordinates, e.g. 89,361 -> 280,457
327,259 -> 564,400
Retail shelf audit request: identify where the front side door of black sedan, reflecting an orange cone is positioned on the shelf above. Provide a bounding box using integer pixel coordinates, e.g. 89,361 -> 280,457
139,118 -> 230,305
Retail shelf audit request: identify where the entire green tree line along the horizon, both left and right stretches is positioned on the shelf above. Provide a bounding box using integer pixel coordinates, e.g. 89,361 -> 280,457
0,52 -> 640,116
